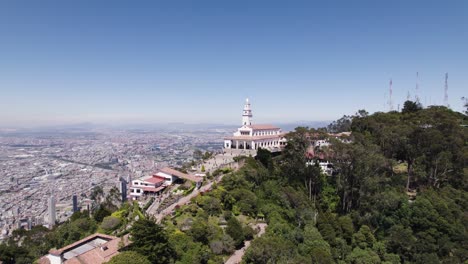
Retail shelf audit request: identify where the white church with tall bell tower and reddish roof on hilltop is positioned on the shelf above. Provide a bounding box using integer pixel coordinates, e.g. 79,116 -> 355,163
224,98 -> 286,151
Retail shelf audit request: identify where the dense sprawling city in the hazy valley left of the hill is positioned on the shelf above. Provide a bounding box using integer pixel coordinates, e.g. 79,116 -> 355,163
0,128 -> 229,239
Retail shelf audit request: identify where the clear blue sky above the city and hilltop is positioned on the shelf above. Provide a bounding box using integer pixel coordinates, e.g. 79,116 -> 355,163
0,0 -> 468,126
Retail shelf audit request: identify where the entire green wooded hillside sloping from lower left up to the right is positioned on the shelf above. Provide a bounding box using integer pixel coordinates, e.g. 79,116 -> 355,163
0,102 -> 468,264
